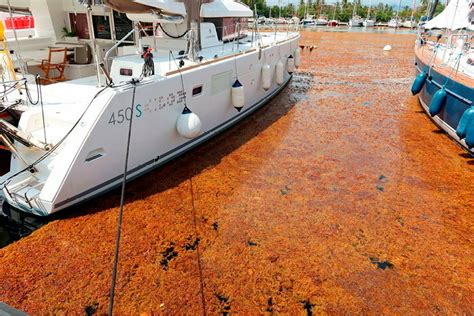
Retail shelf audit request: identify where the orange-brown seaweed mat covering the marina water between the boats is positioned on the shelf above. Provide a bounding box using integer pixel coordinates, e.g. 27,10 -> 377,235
0,32 -> 474,315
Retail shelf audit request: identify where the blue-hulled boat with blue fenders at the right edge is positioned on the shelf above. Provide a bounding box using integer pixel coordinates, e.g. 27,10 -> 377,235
411,0 -> 474,155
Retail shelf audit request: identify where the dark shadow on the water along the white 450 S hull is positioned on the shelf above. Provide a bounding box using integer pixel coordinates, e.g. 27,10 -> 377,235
0,72 -> 313,248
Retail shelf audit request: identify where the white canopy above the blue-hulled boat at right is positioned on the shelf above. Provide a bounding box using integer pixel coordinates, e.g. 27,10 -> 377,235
424,0 -> 472,30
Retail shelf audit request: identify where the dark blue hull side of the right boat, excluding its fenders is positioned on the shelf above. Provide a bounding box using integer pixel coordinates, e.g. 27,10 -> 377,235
415,57 -> 474,154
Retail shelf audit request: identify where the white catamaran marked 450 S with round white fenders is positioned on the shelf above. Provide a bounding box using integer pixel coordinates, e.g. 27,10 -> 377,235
0,0 -> 300,216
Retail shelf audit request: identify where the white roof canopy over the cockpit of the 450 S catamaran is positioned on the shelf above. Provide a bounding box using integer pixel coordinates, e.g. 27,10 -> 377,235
201,0 -> 253,18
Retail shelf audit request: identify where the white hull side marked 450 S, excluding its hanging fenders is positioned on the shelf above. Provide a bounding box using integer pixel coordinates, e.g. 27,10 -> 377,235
2,35 -> 299,216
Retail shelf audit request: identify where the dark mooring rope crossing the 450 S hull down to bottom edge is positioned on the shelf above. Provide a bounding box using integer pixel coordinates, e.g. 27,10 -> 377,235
108,79 -> 138,316
